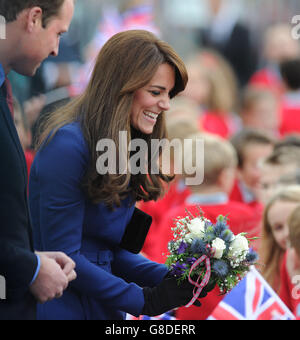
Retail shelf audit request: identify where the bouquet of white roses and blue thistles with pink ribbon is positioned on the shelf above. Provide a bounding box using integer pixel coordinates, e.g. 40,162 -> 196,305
166,209 -> 258,307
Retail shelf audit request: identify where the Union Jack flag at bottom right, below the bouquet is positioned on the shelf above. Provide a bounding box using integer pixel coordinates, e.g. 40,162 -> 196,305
208,268 -> 295,320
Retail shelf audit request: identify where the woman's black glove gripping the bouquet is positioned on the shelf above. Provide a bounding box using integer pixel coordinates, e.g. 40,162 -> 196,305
142,276 -> 207,316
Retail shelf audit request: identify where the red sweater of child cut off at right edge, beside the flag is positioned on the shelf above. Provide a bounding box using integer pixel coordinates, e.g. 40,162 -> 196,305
279,252 -> 300,320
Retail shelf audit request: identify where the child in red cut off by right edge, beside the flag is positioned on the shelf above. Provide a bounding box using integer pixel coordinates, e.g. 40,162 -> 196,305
279,206 -> 300,320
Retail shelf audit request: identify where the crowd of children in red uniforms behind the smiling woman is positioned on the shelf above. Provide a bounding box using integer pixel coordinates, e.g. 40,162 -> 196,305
14,19 -> 300,320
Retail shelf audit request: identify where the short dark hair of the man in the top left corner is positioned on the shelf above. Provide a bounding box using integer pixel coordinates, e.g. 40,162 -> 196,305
0,0 -> 65,27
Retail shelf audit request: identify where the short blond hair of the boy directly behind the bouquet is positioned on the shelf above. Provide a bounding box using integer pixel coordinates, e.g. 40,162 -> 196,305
185,132 -> 237,185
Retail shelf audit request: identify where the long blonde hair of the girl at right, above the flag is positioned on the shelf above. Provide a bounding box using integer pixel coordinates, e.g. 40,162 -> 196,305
259,185 -> 300,291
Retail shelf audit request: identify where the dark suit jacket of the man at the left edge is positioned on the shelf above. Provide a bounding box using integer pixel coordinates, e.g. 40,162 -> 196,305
0,85 -> 37,319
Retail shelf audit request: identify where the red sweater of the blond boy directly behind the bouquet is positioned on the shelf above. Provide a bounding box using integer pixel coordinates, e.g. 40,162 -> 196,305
151,195 -> 260,320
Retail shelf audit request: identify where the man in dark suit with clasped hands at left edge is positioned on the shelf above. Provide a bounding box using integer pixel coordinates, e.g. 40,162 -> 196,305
0,0 -> 76,320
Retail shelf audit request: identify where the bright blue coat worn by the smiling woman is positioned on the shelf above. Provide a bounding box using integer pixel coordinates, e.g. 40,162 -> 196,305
29,123 -> 167,320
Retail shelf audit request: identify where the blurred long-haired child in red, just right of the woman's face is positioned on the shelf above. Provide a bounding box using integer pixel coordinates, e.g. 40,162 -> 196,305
183,50 -> 240,138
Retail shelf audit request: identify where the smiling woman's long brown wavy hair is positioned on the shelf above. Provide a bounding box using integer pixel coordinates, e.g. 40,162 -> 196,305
38,30 -> 188,207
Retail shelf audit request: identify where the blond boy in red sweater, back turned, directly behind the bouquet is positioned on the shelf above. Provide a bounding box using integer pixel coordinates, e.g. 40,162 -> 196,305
156,134 -> 259,320
